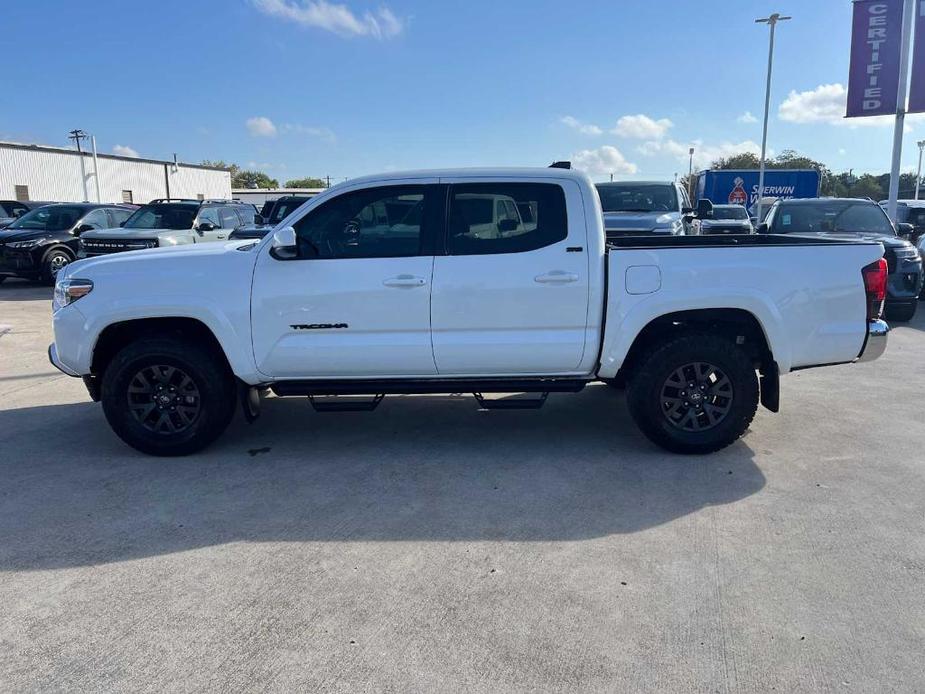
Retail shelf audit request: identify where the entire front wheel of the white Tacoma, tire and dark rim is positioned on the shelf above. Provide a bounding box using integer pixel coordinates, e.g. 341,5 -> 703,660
102,337 -> 236,456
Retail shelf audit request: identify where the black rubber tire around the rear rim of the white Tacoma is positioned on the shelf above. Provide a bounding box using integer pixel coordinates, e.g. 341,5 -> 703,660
626,334 -> 758,454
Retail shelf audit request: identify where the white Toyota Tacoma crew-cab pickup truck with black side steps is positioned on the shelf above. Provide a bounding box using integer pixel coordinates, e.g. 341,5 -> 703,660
49,168 -> 889,455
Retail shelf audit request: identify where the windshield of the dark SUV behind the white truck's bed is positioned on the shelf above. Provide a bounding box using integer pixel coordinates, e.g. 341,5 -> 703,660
771,200 -> 895,236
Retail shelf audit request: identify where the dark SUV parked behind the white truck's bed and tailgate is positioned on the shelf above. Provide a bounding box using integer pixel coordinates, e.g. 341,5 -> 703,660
758,198 -> 923,322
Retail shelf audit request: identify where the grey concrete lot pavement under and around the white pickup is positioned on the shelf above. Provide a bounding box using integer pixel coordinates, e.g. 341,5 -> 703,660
0,281 -> 925,692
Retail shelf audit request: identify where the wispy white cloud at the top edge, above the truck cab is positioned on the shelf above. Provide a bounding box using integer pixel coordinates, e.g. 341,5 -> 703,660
252,0 -> 404,39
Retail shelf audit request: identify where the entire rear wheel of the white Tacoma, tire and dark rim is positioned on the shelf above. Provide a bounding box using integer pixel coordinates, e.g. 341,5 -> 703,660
627,334 -> 758,453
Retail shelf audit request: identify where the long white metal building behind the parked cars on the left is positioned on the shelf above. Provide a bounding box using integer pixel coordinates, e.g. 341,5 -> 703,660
0,142 -> 231,204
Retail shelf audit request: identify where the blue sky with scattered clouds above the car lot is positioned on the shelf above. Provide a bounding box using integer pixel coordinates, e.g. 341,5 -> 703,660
0,0 -> 925,181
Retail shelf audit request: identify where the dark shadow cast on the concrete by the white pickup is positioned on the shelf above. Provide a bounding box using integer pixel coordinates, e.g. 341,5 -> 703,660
0,386 -> 765,571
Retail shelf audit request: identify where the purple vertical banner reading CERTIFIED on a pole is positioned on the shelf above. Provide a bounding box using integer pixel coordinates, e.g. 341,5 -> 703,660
846,0 -> 904,118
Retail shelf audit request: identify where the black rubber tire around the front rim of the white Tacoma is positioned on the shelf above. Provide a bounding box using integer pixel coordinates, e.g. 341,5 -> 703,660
102,337 -> 237,456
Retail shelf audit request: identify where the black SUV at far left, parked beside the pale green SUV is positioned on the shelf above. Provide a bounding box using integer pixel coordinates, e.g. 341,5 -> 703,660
0,203 -> 135,284
